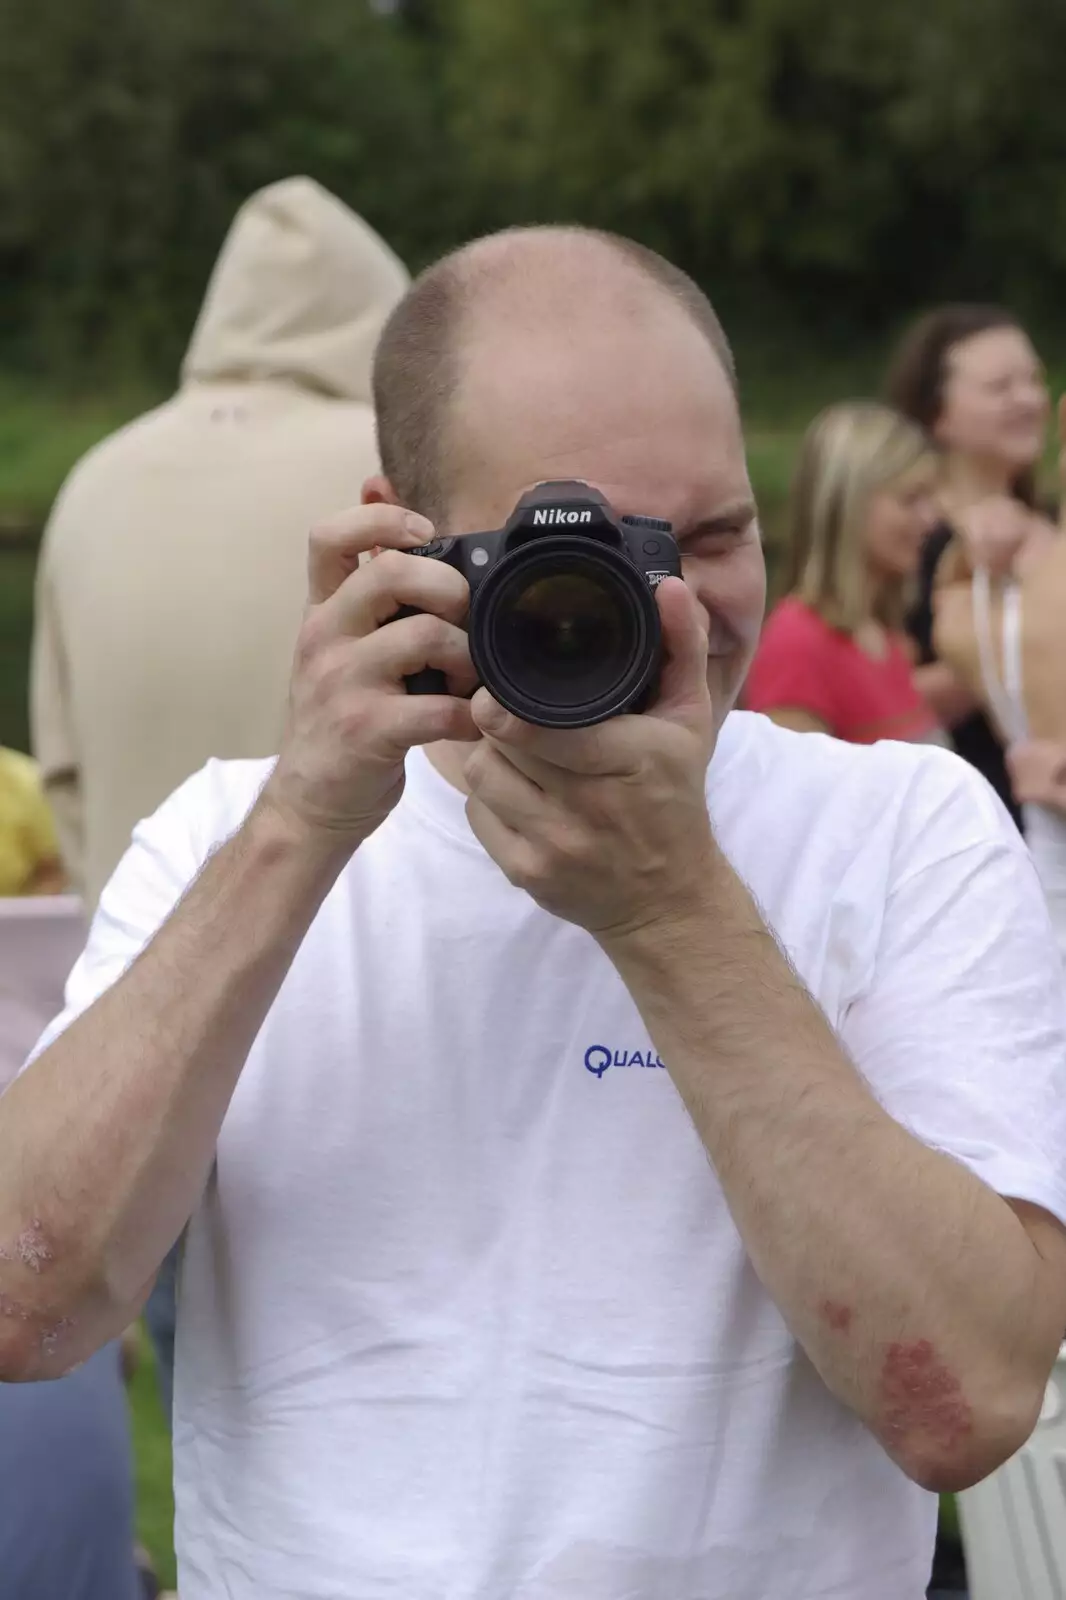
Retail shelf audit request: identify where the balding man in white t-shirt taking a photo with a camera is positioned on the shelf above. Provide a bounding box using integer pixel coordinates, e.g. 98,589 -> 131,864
0,229 -> 1066,1600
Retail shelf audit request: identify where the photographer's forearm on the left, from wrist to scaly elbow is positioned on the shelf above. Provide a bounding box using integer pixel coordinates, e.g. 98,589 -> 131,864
0,803 -> 346,1378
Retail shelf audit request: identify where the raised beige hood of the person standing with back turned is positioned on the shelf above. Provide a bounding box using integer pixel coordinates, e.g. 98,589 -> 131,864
181,178 -> 410,405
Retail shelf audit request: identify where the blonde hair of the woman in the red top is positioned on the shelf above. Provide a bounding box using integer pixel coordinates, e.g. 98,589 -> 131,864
789,400 -> 935,634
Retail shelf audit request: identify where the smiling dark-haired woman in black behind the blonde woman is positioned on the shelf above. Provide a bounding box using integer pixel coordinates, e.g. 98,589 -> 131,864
887,306 -> 1050,819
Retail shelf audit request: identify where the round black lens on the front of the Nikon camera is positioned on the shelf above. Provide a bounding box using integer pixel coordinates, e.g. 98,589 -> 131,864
471,539 -> 659,728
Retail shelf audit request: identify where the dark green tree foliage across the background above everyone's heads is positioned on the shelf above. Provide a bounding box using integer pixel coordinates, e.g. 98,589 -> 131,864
0,0 -> 1066,374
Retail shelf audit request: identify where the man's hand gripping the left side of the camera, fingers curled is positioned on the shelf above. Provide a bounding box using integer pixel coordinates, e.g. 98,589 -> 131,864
259,504 -> 479,848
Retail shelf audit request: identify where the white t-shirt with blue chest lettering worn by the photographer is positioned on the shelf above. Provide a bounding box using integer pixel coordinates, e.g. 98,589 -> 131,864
31,714 -> 1066,1600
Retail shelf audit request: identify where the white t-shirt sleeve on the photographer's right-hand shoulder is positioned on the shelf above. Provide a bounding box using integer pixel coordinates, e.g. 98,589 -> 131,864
842,750 -> 1066,1224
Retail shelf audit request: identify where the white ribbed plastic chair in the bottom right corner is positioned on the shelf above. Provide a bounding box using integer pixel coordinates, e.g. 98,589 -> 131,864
959,1344 -> 1066,1600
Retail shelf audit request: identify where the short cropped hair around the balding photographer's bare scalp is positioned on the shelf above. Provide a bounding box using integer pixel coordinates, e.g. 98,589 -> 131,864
373,227 -> 736,523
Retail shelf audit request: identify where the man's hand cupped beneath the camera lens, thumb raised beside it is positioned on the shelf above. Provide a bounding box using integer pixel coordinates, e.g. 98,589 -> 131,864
466,578 -> 715,938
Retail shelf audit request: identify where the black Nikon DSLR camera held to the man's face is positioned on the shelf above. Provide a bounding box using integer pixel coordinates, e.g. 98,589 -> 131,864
407,483 -> 680,728
